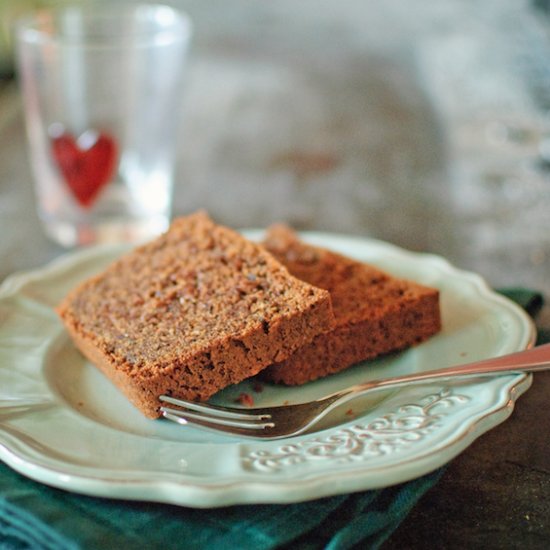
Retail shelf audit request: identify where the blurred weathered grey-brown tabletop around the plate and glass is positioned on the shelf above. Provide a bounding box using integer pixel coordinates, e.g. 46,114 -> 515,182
0,0 -> 550,550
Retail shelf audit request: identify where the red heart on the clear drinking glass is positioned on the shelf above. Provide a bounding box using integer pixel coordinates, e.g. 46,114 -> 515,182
51,130 -> 117,208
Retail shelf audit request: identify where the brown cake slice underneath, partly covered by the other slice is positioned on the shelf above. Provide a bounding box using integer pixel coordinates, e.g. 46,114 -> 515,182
261,225 -> 441,385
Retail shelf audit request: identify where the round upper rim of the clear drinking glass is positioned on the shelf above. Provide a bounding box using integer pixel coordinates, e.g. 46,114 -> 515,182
14,2 -> 192,48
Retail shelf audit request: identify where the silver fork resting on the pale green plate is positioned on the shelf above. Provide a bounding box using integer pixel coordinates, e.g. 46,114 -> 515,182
159,344 -> 550,440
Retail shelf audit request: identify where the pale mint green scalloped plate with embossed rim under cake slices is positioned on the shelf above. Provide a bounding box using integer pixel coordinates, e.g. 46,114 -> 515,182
0,232 -> 535,507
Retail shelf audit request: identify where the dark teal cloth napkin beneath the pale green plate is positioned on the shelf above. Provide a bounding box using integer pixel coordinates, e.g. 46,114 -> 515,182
0,289 -> 543,550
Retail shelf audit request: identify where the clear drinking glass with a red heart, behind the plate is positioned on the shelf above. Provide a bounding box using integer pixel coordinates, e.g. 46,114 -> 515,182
16,2 -> 191,246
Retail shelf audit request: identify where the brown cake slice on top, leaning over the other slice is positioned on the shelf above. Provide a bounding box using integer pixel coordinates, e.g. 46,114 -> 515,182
57,213 -> 334,418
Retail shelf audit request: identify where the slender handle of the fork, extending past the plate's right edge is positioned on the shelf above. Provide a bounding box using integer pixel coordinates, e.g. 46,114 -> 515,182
341,344 -> 550,397
